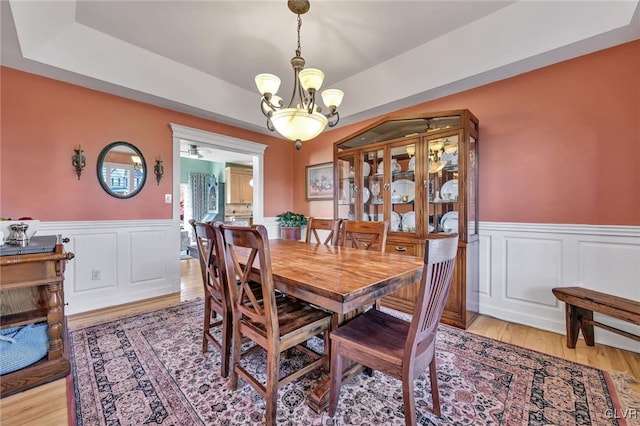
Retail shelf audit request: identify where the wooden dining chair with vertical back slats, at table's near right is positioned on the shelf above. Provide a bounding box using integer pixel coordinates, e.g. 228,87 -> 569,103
329,234 -> 458,425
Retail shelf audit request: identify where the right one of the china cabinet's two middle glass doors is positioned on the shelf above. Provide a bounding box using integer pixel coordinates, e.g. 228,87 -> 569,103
389,138 -> 420,233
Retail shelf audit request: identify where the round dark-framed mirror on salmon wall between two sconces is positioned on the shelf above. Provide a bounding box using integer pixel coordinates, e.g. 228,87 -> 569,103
98,142 -> 147,198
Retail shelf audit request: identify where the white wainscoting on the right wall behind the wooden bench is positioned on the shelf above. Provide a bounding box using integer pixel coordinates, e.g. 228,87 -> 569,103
479,222 -> 640,352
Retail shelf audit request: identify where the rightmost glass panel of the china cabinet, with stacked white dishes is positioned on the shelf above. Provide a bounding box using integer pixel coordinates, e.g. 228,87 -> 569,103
426,132 -> 464,234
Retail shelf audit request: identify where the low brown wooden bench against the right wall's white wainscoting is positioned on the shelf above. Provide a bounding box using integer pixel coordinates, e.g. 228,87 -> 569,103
551,287 -> 640,348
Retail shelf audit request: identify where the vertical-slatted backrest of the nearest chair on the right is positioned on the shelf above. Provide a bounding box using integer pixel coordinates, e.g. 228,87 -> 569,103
405,234 -> 458,362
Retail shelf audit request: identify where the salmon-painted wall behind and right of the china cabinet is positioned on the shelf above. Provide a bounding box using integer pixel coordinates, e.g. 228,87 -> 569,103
294,41 -> 640,226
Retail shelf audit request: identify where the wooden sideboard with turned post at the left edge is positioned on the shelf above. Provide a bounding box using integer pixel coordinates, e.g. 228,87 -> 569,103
0,236 -> 74,397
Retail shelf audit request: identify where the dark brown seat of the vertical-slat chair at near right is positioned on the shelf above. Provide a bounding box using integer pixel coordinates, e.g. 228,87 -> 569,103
331,309 -> 411,366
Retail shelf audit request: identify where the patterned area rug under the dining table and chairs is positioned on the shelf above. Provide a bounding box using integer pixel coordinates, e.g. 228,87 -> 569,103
71,300 -> 640,426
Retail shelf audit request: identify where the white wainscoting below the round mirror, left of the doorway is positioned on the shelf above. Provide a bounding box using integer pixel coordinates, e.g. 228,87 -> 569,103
38,219 -> 180,315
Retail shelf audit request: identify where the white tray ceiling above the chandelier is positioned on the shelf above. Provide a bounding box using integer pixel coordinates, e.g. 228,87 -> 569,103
0,0 -> 640,154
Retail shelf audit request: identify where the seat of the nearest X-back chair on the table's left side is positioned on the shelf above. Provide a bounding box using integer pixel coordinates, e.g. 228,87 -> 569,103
243,296 -> 331,339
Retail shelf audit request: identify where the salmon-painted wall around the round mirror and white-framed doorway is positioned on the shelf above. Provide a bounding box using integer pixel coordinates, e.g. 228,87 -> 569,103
0,67 -> 295,221
